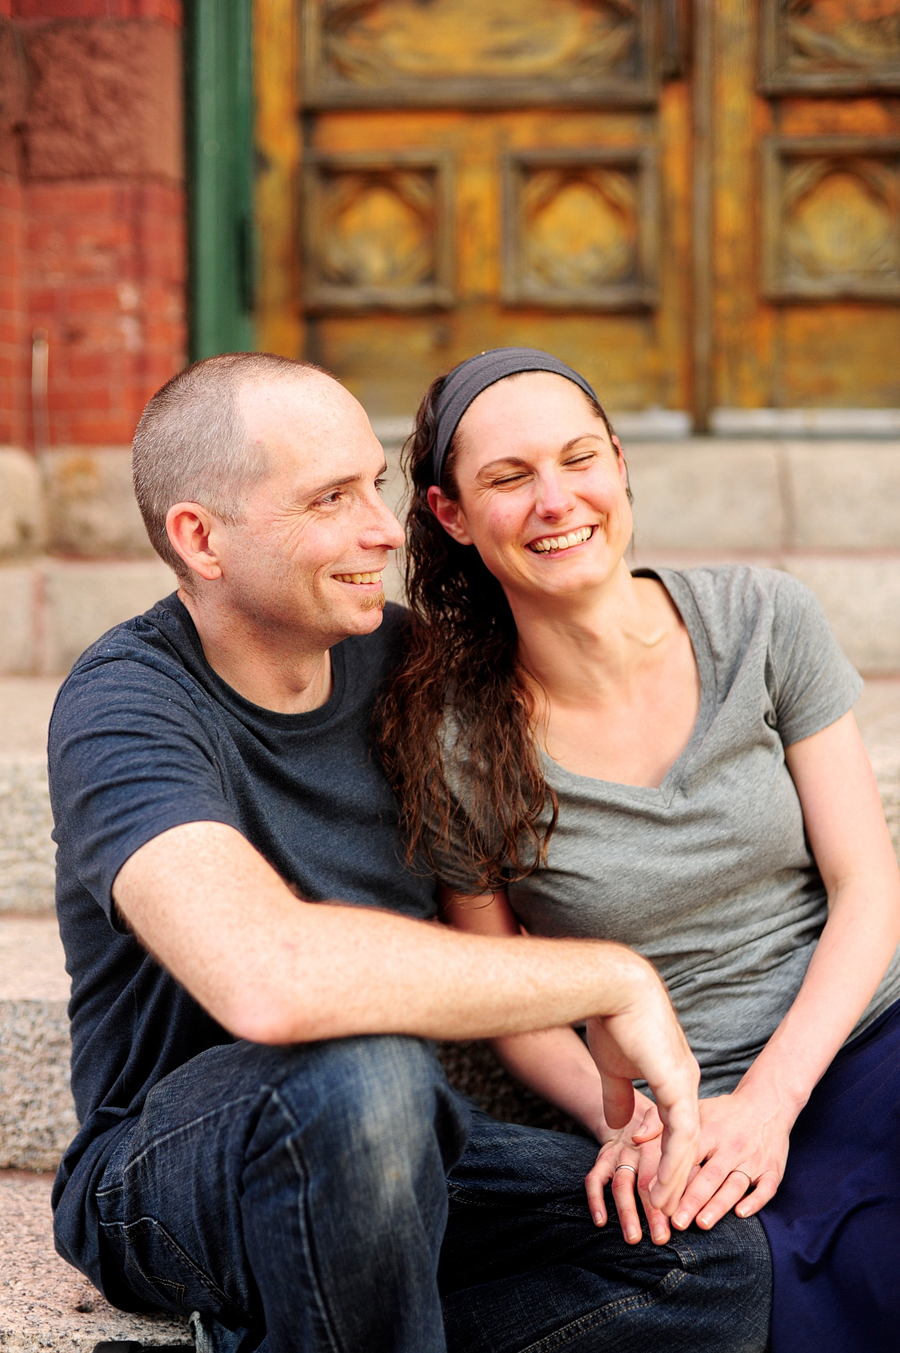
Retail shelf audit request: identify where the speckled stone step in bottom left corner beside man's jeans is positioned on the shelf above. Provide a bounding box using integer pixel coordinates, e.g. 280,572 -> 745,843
0,1170 -> 194,1353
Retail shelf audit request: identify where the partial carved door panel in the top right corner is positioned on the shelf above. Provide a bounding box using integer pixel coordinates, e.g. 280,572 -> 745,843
762,0 -> 900,93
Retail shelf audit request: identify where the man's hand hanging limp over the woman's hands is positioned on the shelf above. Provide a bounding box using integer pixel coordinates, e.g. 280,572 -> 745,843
587,965 -> 700,1216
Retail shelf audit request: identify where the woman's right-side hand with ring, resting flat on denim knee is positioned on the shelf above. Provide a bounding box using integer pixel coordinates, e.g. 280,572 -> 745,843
671,1086 -> 796,1231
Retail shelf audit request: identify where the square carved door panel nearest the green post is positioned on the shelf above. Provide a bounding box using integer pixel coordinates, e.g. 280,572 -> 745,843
305,152 -> 453,310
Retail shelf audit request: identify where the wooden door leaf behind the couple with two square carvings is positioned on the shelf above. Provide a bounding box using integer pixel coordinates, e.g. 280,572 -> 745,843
284,0 -> 690,417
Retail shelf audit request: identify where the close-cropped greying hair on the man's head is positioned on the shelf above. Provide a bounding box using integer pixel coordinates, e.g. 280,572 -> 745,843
131,352 -> 332,582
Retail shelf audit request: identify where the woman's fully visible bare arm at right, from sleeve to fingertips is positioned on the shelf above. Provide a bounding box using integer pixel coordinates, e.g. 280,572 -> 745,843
673,713 -> 900,1229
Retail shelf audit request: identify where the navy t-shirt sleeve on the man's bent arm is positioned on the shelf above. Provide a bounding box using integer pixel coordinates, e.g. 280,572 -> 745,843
49,660 -> 238,930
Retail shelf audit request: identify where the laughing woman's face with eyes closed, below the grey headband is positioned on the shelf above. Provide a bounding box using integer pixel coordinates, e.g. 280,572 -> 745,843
428,371 -> 632,601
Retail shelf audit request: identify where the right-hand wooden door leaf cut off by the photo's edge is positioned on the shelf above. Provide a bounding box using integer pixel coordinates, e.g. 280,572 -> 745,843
712,0 -> 900,416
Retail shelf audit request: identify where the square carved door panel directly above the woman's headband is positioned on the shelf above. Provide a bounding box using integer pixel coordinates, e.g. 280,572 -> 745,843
503,146 -> 658,310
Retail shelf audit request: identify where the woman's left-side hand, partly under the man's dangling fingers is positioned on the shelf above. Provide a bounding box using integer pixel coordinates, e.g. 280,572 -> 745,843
585,1091 -> 671,1245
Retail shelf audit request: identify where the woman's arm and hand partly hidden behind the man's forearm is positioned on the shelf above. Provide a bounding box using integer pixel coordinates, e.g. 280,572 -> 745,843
440,888 -> 670,1245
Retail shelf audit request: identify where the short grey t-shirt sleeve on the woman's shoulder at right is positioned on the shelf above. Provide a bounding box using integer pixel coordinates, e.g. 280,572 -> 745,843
769,574 -> 862,747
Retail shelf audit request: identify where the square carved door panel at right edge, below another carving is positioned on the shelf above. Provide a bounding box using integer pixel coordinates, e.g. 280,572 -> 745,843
763,137 -> 900,300
